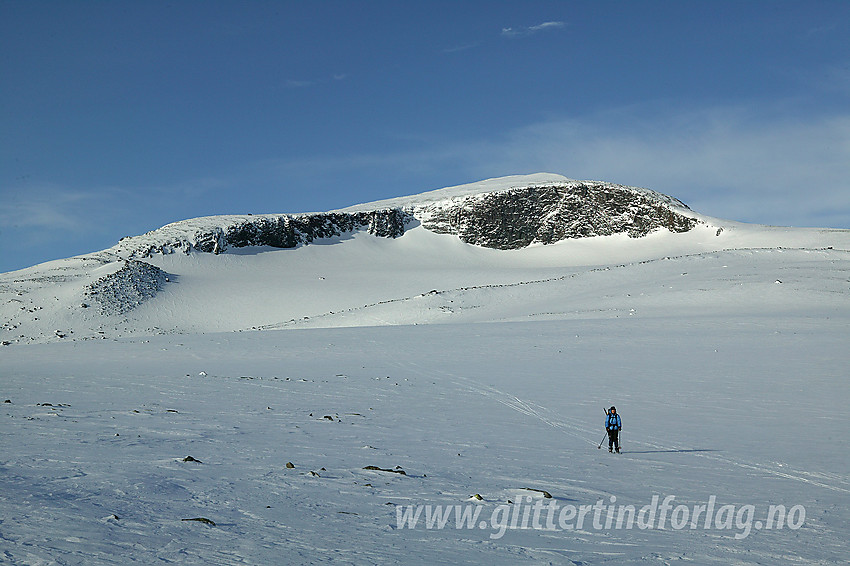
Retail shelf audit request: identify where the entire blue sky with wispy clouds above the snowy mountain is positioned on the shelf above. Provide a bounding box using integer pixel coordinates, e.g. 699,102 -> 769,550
0,0 -> 850,271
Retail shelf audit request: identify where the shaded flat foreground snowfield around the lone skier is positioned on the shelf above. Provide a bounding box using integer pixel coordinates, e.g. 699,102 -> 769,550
0,318 -> 850,565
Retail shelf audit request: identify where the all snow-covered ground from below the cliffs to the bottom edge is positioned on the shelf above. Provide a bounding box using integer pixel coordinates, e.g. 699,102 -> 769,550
0,175 -> 850,565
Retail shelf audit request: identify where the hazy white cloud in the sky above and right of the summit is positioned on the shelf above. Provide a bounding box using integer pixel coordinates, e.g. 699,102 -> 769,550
464,108 -> 850,227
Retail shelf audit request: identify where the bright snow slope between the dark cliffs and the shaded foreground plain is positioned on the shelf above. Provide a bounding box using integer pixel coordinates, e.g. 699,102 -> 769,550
0,215 -> 850,344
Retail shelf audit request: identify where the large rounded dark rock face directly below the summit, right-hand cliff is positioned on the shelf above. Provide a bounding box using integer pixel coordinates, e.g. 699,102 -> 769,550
414,183 -> 697,249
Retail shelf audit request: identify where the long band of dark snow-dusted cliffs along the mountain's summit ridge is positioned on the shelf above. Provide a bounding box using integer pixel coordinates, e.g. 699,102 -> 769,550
113,178 -> 697,258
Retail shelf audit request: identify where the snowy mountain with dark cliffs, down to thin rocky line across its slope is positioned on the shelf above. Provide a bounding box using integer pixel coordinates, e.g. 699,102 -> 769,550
0,173 -> 848,345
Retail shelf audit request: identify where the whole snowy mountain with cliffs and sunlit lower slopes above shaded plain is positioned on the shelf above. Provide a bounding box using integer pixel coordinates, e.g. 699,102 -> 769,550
0,174 -> 850,345
